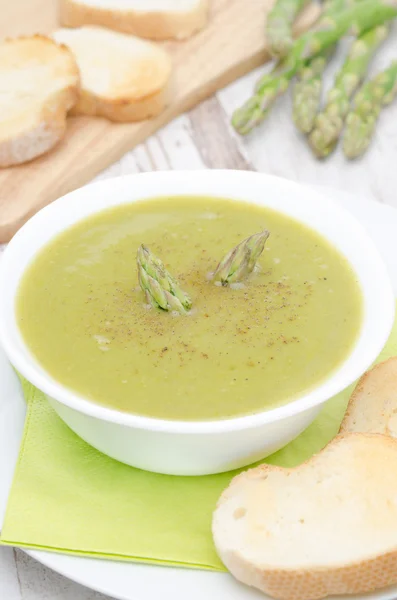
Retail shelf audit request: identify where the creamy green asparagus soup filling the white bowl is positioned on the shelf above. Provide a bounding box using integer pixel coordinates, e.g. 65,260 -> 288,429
17,197 -> 362,420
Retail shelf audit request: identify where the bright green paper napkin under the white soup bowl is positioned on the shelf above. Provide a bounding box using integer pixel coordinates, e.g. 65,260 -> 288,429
1,310 -> 397,570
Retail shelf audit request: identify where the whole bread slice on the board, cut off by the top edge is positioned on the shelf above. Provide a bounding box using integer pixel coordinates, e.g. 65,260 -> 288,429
61,0 -> 209,40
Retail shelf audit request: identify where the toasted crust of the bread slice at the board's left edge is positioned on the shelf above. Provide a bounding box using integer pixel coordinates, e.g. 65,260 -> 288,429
0,35 -> 80,167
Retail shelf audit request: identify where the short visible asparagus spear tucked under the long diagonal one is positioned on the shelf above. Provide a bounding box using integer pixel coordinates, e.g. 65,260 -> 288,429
292,46 -> 335,134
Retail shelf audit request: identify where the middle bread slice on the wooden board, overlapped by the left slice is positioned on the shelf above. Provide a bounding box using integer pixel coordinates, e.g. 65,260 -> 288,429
53,27 -> 172,122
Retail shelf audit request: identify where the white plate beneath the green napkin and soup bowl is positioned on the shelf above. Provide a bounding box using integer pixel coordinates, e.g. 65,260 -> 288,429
0,188 -> 397,600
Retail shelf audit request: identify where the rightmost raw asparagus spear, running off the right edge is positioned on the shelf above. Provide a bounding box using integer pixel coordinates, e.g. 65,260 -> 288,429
343,60 -> 397,159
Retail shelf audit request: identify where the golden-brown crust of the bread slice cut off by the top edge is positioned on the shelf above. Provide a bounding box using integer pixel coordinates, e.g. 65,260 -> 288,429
60,0 -> 209,40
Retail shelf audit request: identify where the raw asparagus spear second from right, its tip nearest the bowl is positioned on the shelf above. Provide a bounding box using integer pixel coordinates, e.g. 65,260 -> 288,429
309,24 -> 390,158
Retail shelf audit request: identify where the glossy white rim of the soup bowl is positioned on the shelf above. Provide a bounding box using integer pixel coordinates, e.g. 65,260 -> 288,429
0,169 -> 395,435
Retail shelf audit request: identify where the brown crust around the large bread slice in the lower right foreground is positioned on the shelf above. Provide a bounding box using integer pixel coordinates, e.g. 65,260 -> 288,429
212,433 -> 397,600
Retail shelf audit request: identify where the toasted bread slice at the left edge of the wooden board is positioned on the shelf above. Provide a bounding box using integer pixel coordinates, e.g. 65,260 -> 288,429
0,35 -> 79,167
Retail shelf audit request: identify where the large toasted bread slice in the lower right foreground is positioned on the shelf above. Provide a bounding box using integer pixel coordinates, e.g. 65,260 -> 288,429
213,433 -> 397,600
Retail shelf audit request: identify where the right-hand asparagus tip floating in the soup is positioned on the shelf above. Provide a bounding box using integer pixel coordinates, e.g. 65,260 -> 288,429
212,230 -> 270,286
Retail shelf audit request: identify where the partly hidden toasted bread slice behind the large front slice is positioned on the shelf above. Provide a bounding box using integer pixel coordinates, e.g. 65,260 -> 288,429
340,357 -> 397,437
